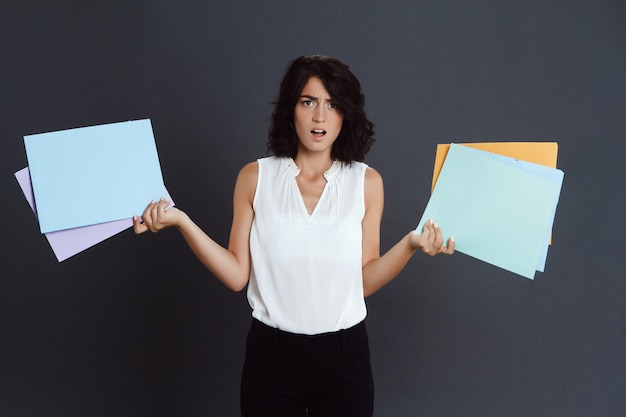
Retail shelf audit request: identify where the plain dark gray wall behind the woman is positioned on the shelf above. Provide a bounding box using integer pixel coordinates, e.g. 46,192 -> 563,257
0,0 -> 626,417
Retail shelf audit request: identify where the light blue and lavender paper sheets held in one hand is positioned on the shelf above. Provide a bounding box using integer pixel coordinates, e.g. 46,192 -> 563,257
15,119 -> 170,262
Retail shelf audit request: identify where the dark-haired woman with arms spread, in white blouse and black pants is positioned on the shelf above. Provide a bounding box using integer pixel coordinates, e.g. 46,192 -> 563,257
134,56 -> 454,417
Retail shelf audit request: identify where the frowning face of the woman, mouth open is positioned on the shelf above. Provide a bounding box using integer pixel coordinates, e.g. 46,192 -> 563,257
294,77 -> 343,154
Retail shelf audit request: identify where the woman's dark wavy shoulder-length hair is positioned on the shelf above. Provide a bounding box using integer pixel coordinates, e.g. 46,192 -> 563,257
267,55 -> 374,163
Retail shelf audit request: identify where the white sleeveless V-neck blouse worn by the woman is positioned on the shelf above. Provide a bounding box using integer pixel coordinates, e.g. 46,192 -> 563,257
248,157 -> 367,335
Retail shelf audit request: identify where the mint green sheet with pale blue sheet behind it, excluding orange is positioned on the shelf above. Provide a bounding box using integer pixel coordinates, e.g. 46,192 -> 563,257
416,144 -> 563,279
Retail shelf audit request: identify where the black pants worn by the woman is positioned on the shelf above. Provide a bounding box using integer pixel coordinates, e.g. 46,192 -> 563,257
241,320 -> 374,417
